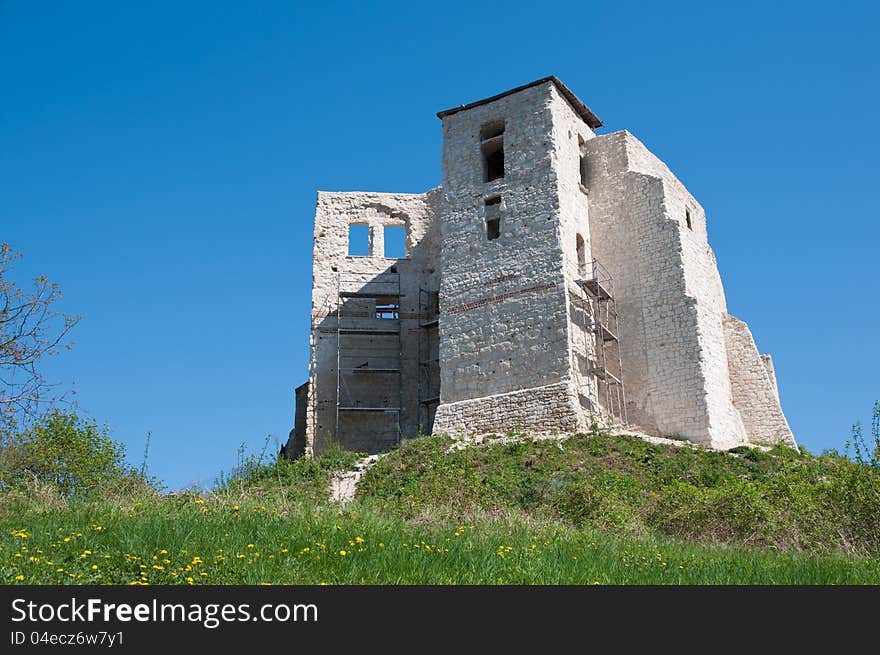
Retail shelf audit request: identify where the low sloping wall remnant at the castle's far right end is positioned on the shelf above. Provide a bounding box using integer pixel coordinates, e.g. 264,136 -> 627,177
724,314 -> 795,447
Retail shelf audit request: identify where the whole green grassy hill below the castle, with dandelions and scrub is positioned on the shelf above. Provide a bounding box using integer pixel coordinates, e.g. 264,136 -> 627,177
0,433 -> 880,584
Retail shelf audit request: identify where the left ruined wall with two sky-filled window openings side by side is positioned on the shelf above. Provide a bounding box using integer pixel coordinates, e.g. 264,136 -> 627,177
306,190 -> 439,453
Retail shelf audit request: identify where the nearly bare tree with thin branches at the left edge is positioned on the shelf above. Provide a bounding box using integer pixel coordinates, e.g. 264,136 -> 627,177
0,243 -> 80,422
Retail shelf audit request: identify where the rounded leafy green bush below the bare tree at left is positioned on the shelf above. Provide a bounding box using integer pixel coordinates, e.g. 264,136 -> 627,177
0,410 -> 147,497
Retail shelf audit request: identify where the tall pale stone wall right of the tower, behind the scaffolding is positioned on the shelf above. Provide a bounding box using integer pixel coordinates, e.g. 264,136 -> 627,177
587,132 -> 745,448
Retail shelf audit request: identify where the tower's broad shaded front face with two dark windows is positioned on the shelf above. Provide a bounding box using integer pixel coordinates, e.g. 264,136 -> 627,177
435,82 -> 578,432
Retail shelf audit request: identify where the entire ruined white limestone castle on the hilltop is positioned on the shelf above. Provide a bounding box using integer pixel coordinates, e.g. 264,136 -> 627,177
285,77 -> 795,456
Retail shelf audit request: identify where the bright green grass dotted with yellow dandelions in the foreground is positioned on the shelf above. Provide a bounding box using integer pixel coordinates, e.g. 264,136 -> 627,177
0,496 -> 880,584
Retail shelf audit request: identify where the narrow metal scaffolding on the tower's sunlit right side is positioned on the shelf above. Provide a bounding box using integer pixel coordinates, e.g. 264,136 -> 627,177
576,259 -> 629,425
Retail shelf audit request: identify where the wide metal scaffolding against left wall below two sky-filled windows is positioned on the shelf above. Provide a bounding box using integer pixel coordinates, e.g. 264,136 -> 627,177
335,272 -> 403,445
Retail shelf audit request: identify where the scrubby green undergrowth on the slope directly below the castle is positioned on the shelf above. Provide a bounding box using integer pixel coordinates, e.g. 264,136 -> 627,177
358,434 -> 880,557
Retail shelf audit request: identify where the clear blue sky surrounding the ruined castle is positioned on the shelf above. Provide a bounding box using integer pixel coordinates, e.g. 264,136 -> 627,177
0,0 -> 880,488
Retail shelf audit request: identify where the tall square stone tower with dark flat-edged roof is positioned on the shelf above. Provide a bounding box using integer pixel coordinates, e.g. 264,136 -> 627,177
434,79 -> 602,432
